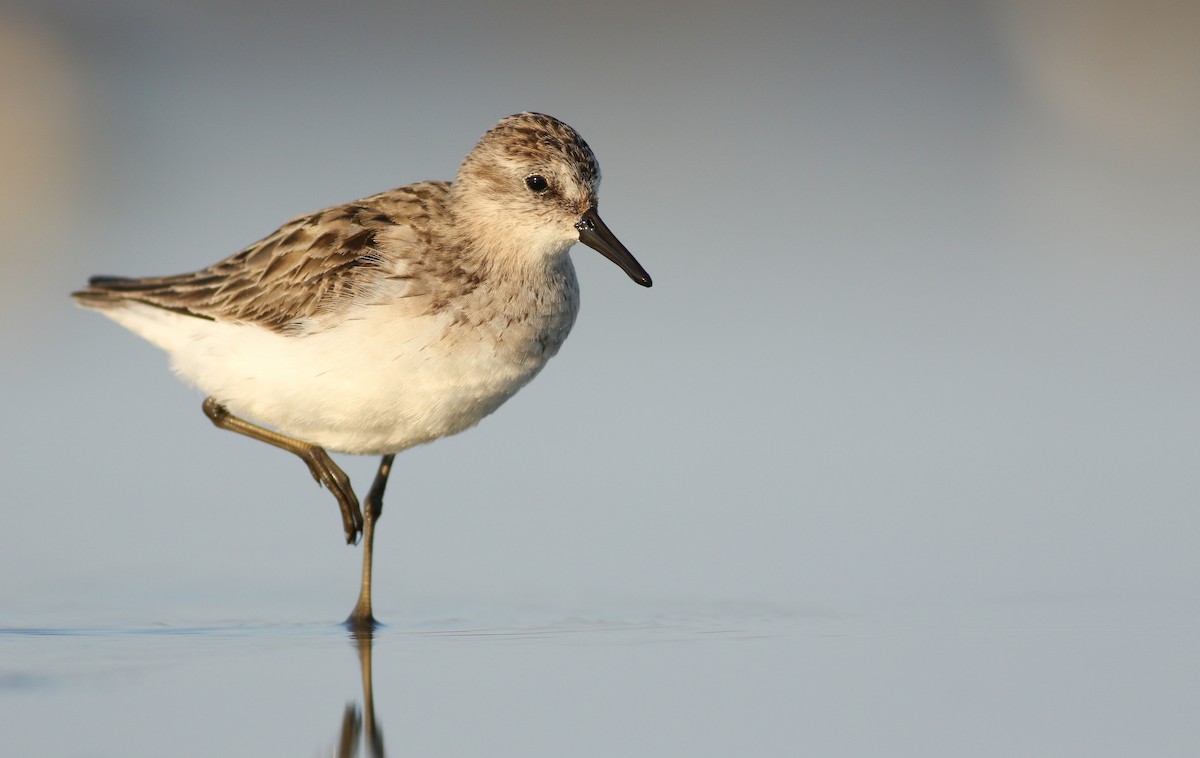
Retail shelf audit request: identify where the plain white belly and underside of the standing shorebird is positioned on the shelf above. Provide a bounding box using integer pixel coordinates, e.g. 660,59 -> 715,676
106,295 -> 575,455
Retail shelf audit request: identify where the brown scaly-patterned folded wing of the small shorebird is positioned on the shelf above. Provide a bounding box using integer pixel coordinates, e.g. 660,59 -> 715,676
74,182 -> 449,330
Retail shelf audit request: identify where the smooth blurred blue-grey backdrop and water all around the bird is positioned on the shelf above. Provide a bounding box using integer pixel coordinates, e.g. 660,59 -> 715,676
0,0 -> 1200,756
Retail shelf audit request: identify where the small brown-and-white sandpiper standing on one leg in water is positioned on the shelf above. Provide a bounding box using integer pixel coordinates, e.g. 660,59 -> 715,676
72,112 -> 652,631
